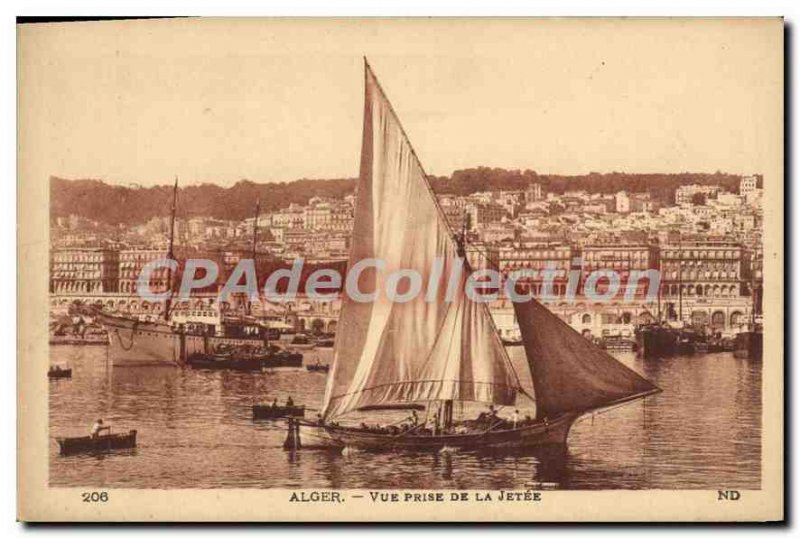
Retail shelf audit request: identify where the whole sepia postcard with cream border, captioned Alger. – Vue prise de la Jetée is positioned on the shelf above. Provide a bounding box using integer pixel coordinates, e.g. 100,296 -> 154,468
17,18 -> 784,522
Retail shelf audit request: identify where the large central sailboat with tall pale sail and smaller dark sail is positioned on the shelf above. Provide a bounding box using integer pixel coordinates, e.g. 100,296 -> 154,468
284,59 -> 660,451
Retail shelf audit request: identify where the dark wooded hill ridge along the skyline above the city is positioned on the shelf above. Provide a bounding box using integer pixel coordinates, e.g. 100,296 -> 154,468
50,167 -> 752,224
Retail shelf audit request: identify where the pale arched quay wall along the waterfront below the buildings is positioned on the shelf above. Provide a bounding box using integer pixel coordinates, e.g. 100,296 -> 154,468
50,292 -> 752,337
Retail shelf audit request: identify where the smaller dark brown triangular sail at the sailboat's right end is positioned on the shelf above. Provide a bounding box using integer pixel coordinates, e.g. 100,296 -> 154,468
514,298 -> 660,418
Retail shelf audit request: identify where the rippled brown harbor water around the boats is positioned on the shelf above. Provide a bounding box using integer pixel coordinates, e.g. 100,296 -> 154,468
49,346 -> 761,489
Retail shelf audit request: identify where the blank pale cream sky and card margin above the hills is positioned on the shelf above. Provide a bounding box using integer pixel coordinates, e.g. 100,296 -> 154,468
19,20 -> 782,185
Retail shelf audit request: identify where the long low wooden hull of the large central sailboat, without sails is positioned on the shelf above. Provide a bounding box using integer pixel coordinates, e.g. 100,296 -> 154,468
290,413 -> 579,452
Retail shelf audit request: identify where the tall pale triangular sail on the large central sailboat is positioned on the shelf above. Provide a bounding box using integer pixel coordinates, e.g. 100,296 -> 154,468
323,60 -> 521,419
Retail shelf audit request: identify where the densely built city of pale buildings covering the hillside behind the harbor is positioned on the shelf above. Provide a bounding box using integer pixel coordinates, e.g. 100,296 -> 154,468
50,176 -> 763,338
